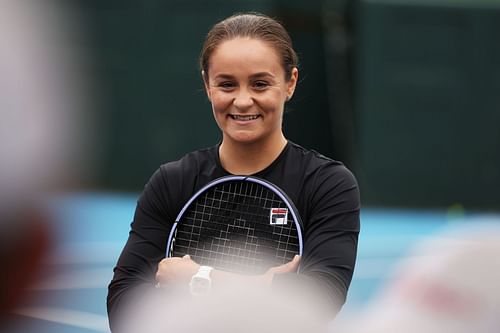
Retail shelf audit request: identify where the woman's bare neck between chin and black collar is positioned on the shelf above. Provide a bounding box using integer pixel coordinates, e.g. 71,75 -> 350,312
219,135 -> 287,175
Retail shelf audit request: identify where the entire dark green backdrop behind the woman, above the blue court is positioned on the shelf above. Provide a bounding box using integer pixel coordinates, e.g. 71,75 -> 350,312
75,0 -> 500,209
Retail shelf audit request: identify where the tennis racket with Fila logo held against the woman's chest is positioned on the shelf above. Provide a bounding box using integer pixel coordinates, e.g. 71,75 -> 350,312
167,176 -> 303,274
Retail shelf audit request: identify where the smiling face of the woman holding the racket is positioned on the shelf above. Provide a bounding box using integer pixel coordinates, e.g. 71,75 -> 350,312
205,38 -> 298,143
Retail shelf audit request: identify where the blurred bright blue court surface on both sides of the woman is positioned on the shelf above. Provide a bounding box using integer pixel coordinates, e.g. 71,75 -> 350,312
1,193 -> 500,333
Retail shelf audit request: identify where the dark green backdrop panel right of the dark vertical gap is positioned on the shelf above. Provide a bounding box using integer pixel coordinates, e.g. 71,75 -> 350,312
355,1 -> 500,208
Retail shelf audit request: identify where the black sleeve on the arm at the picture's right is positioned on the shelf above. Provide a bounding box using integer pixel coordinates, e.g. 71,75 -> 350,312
273,164 -> 360,316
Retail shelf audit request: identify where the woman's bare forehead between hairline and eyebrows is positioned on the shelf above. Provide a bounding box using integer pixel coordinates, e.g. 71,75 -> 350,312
209,38 -> 284,75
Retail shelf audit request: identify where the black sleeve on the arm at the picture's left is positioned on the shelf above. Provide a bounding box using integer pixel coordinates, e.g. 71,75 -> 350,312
107,168 -> 180,331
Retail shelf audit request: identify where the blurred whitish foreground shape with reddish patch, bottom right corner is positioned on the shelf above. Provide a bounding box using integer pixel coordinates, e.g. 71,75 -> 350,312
340,223 -> 500,333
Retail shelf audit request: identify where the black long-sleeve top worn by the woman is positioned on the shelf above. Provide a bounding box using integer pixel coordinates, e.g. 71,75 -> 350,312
107,142 -> 360,330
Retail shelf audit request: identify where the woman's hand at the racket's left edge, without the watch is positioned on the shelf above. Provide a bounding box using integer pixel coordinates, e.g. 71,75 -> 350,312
156,255 -> 200,286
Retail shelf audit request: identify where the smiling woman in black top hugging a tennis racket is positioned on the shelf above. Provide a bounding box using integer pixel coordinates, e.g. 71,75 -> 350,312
108,14 -> 360,327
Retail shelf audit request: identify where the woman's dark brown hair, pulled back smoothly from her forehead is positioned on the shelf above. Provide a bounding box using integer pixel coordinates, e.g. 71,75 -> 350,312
199,13 -> 298,81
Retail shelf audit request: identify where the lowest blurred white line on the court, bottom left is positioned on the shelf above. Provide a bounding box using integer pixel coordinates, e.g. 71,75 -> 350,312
14,307 -> 110,333
